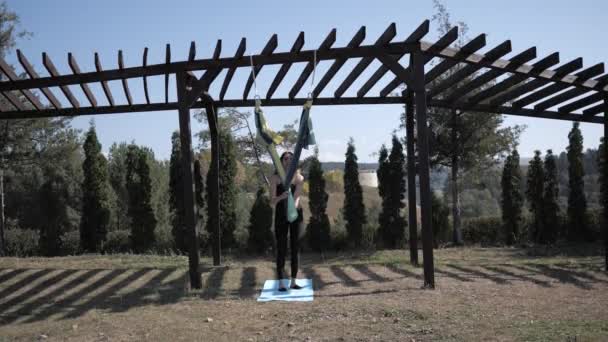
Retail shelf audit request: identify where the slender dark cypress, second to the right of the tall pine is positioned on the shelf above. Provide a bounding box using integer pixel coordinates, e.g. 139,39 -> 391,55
526,151 -> 545,242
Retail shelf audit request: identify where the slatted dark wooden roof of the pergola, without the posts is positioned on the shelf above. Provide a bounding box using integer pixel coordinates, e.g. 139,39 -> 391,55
0,21 -> 608,123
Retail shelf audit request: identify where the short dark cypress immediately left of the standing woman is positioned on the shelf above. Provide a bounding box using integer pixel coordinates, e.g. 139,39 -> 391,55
248,187 -> 273,254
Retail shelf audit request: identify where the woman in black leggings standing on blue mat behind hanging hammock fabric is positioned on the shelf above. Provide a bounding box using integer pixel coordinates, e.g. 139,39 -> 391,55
270,151 -> 304,292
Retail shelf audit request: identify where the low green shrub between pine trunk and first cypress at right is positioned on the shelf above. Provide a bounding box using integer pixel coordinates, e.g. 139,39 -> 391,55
462,216 -> 504,246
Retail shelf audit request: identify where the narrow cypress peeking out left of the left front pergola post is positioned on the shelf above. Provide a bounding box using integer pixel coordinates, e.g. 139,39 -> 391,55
169,131 -> 188,254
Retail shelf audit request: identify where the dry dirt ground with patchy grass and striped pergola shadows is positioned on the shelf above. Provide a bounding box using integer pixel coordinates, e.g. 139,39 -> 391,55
0,248 -> 608,341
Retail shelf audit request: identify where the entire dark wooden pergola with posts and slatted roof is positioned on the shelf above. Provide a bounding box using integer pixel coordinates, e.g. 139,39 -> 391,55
0,20 -> 608,288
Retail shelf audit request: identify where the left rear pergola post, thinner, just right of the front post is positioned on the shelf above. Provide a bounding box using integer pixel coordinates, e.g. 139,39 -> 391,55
205,103 -> 222,266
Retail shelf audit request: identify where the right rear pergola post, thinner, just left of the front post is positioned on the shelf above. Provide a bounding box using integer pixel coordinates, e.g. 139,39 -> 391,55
405,87 -> 418,266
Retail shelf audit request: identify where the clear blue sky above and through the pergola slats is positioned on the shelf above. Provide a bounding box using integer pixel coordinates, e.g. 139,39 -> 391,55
7,0 -> 608,162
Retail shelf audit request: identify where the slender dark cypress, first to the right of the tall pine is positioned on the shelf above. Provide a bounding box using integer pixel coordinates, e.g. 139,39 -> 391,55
501,150 -> 523,245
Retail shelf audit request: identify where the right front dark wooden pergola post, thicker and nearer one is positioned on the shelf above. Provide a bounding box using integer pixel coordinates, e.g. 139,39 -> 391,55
412,51 -> 435,289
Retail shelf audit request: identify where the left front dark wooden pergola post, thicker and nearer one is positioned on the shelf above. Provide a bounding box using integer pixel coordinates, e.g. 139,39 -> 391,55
175,72 -> 202,289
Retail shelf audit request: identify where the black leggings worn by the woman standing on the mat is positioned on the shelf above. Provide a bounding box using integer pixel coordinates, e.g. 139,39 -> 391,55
274,208 -> 303,279
